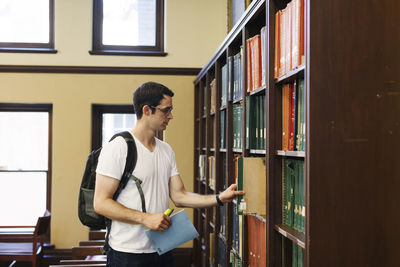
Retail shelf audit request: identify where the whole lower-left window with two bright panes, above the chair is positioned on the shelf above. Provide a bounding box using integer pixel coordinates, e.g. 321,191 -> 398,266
0,103 -> 52,226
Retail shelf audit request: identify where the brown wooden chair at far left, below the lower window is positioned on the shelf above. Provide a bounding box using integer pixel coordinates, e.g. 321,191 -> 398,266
0,210 -> 51,267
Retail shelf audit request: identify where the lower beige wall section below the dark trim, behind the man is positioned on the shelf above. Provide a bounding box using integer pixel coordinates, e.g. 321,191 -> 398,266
0,74 -> 195,248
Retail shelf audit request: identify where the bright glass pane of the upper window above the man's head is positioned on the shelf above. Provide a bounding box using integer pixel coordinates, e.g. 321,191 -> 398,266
103,0 -> 156,46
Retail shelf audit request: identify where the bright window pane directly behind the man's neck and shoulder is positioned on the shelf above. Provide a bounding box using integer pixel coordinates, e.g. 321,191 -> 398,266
102,113 -> 136,145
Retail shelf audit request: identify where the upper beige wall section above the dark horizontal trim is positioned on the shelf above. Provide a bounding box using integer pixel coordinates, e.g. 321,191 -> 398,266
0,0 -> 226,67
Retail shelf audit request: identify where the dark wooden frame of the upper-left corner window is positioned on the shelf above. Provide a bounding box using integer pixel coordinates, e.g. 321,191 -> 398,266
0,0 -> 57,54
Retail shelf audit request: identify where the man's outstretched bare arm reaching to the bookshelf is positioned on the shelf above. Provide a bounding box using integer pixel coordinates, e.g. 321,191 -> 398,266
169,175 -> 244,208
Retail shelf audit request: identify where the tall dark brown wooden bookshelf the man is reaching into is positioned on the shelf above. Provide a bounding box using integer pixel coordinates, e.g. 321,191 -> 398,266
193,0 -> 400,267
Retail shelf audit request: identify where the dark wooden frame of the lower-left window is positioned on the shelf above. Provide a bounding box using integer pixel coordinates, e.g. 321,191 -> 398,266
0,103 -> 53,242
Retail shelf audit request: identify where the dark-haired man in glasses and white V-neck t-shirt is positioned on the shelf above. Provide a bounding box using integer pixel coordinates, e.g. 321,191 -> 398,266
94,82 -> 244,267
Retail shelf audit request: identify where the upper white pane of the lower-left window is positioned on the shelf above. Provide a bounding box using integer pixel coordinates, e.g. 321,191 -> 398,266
0,112 -> 49,170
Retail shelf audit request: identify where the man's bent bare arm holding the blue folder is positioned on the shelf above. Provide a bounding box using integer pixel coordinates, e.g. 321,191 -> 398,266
93,174 -> 171,231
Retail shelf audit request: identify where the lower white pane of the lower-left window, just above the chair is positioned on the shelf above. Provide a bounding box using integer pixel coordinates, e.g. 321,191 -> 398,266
0,172 -> 47,226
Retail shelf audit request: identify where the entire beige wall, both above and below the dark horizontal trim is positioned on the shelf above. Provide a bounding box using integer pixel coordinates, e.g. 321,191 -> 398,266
0,0 -> 226,249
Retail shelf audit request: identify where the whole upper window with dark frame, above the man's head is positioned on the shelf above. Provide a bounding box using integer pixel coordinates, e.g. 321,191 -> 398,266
90,0 -> 166,56
